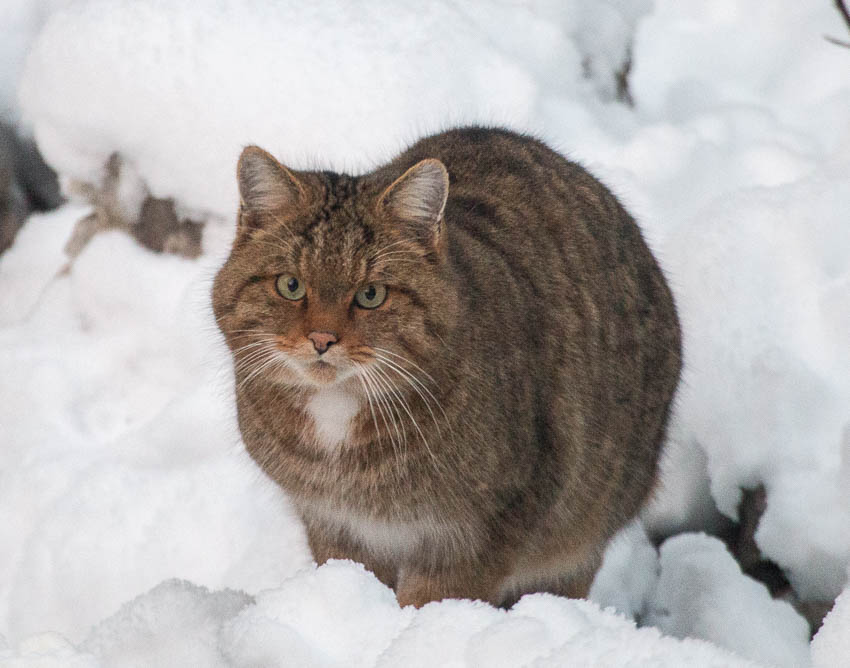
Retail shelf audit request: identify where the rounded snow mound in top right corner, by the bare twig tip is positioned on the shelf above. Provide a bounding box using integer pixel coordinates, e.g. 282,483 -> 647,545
632,0 -> 850,146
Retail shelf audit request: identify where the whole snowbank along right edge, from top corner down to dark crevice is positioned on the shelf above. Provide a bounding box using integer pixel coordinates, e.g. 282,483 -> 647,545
619,0 -> 850,600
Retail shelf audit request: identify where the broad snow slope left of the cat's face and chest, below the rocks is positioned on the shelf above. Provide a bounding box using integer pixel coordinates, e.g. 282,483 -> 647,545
0,230 -> 309,640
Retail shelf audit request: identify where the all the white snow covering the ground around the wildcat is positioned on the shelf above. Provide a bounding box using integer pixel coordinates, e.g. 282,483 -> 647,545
0,0 -> 850,668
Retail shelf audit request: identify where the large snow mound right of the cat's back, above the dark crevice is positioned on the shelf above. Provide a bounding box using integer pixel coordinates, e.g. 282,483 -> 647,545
667,155 -> 850,600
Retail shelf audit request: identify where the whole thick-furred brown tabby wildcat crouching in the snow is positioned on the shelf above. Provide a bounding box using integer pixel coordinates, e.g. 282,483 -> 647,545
213,127 -> 681,606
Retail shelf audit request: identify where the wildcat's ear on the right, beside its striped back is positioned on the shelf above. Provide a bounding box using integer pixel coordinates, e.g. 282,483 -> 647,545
379,158 -> 449,243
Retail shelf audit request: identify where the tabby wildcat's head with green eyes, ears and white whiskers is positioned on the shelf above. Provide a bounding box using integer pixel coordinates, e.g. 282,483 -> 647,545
213,147 -> 458,394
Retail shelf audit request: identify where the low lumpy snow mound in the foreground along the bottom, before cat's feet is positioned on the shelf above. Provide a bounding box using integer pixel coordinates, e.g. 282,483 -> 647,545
0,561 -> 757,668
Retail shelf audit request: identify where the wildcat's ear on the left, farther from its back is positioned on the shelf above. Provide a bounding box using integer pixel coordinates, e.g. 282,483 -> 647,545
236,146 -> 304,212
